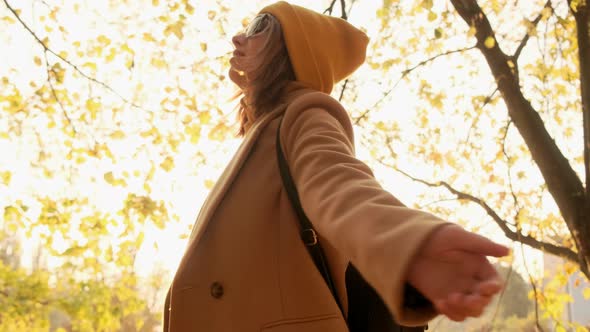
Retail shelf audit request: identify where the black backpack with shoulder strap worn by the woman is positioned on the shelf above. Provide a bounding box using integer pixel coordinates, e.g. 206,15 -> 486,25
276,119 -> 430,332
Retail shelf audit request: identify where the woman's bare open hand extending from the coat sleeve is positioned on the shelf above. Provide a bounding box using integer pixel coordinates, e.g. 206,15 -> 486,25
407,224 -> 509,321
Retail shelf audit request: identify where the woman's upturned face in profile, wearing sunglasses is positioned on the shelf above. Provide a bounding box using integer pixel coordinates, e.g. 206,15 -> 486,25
229,14 -> 267,89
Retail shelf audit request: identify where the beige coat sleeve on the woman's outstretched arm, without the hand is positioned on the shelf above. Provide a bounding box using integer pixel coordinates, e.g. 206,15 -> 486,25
281,102 -> 445,326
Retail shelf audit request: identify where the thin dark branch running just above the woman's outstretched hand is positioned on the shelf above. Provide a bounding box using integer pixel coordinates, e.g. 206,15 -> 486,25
393,163 -> 580,264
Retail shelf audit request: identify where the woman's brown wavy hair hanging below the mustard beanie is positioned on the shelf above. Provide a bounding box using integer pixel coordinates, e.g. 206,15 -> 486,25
236,13 -> 295,136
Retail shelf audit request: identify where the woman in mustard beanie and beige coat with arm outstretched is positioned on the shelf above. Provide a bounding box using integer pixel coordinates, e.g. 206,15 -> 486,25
164,2 -> 508,332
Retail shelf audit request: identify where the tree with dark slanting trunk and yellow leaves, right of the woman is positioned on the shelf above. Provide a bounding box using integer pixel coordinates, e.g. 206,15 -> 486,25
353,0 -> 590,277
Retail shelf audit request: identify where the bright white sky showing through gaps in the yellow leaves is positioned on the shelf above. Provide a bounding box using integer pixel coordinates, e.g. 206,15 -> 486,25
0,0 -> 556,288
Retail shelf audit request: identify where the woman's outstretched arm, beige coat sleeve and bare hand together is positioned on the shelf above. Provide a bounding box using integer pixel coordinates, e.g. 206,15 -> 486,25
281,100 -> 506,325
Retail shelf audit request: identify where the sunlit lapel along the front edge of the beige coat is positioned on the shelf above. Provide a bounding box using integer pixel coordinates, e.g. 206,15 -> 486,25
179,105 -> 285,270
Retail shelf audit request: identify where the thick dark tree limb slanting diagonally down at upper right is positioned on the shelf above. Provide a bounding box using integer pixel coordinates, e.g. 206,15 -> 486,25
451,0 -> 584,244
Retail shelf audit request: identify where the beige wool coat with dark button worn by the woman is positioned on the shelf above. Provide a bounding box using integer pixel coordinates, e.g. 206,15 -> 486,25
164,90 -> 442,332
